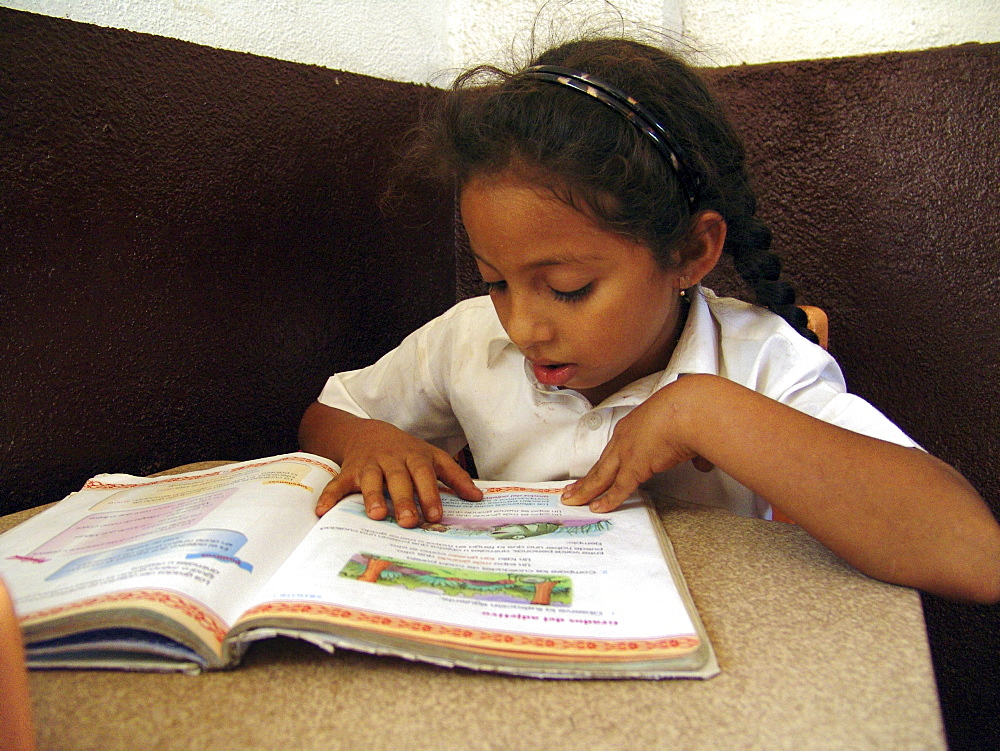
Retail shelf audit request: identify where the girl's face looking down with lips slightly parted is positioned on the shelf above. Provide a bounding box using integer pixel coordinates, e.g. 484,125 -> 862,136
460,173 -> 683,404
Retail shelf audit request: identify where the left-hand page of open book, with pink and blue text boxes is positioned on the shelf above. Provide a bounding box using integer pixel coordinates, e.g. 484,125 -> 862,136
0,454 -> 336,643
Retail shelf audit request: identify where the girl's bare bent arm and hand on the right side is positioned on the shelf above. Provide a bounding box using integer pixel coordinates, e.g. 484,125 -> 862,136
564,375 -> 1000,603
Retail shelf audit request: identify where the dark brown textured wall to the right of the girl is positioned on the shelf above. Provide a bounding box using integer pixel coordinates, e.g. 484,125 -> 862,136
705,44 -> 1000,750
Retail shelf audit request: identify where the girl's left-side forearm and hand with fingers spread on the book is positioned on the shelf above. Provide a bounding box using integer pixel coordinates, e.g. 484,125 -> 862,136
299,402 -> 483,527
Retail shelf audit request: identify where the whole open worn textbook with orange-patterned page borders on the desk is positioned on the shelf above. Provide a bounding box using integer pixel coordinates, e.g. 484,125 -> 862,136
0,453 -> 719,678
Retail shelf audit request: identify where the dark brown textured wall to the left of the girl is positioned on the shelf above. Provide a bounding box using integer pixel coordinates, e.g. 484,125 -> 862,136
0,9 -> 454,513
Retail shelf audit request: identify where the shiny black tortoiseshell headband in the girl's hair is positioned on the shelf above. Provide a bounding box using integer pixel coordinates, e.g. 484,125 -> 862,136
521,65 -> 700,208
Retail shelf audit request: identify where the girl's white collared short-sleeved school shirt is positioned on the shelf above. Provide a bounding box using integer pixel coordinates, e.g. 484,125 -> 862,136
319,287 -> 916,517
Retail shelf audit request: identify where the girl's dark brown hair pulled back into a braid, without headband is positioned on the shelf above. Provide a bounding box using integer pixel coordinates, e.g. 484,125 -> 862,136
404,38 -> 816,341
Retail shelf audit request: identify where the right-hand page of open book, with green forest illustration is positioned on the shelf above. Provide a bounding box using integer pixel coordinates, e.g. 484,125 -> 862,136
237,483 -> 700,661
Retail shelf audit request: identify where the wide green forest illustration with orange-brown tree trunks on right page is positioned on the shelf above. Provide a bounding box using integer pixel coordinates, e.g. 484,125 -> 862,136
340,553 -> 572,606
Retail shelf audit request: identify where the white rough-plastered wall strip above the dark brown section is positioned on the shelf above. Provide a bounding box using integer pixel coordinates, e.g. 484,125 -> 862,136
0,0 -> 1000,84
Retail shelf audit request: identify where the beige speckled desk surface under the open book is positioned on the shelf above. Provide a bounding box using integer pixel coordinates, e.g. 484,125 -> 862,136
0,468 -> 945,751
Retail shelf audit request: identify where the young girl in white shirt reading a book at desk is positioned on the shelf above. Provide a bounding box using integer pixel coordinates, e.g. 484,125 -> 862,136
300,39 -> 1000,602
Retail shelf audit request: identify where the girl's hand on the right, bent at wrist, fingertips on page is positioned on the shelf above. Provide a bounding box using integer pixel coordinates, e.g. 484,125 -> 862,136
562,384 -> 712,513
